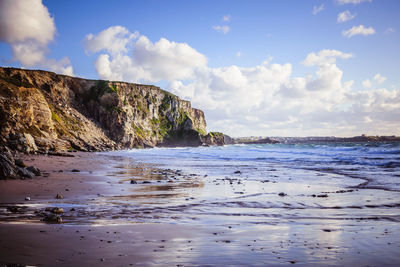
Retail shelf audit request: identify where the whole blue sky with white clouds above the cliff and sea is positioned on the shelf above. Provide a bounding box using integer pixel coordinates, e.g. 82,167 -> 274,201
0,0 -> 400,137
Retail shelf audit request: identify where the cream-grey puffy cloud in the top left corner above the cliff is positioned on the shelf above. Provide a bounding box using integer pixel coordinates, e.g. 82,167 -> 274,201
0,0 -> 73,75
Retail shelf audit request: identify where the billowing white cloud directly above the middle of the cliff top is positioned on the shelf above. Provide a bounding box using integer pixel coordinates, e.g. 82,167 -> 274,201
85,26 -> 207,83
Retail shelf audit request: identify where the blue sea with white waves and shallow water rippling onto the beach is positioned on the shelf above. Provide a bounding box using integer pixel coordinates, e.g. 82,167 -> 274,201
105,142 -> 400,225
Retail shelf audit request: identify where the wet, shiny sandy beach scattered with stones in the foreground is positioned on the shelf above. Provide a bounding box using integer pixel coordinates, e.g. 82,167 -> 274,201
0,153 -> 400,266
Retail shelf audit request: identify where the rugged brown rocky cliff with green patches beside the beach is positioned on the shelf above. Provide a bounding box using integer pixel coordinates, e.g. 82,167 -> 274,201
0,68 -> 213,152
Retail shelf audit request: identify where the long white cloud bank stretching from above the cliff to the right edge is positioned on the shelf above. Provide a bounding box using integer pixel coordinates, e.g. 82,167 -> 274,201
85,26 -> 400,136
